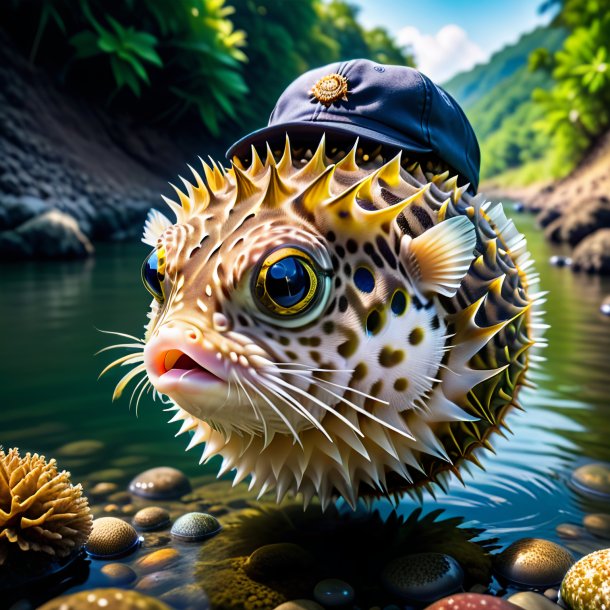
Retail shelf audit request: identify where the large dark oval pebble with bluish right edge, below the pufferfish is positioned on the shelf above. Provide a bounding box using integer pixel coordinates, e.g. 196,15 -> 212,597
381,553 -> 464,603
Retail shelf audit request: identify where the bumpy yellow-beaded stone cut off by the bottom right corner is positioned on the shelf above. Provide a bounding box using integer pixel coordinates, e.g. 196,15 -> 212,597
561,549 -> 610,610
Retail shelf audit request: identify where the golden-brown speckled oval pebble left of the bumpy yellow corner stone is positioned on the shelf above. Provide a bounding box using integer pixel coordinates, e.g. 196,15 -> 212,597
494,538 -> 574,588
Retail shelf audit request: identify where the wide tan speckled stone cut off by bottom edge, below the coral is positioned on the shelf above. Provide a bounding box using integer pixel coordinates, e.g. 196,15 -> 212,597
38,589 -> 171,610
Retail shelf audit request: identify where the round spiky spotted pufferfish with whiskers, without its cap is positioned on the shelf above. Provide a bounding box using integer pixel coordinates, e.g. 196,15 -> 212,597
102,135 -> 544,507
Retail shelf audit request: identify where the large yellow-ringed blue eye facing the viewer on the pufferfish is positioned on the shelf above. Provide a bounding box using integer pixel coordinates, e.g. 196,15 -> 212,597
254,248 -> 330,317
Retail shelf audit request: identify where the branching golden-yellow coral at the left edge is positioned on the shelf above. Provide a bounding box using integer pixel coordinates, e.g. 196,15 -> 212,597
0,448 -> 92,565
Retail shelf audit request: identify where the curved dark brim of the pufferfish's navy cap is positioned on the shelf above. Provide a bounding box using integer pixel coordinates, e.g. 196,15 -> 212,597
226,121 -> 433,160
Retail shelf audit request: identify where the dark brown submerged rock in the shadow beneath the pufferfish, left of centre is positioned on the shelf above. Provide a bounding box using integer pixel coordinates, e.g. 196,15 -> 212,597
244,542 -> 315,582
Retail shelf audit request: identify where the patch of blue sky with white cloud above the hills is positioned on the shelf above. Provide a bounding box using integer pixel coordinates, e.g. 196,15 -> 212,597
351,0 -> 552,83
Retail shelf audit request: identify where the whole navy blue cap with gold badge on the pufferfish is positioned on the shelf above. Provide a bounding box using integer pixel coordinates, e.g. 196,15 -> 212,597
226,59 -> 480,191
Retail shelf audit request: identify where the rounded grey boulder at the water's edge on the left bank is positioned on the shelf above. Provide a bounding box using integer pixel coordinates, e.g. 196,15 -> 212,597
0,210 -> 93,259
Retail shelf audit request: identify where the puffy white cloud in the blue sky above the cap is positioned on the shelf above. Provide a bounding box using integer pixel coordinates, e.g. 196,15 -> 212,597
397,23 -> 488,83
